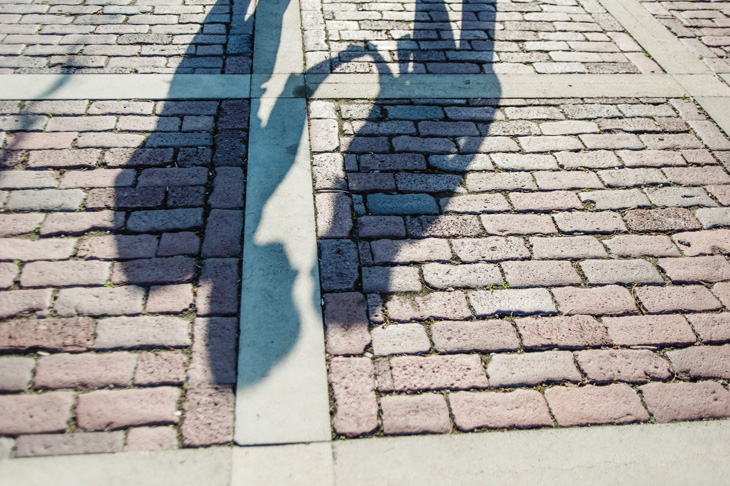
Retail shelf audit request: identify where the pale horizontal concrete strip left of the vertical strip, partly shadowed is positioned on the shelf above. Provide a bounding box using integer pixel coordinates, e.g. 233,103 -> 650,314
0,74 -> 251,100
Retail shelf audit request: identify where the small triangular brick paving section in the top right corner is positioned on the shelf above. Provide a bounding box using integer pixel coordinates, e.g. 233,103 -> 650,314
642,1 -> 730,73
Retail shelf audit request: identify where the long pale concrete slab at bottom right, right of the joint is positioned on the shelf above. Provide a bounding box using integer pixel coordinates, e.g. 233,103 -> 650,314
334,420 -> 730,486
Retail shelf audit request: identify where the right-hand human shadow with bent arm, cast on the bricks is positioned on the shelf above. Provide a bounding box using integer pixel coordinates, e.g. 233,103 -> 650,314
319,0 -> 500,318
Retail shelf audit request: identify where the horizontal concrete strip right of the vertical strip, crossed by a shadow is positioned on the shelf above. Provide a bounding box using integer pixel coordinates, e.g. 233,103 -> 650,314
307,74 -> 687,98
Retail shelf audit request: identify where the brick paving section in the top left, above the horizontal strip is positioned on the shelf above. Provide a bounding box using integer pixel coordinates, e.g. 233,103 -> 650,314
0,0 -> 253,74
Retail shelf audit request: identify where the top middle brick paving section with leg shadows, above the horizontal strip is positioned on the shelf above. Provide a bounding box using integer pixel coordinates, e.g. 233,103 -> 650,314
302,0 -> 662,74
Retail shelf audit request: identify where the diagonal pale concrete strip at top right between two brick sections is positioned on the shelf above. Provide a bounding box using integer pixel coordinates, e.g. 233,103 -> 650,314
599,0 -> 711,74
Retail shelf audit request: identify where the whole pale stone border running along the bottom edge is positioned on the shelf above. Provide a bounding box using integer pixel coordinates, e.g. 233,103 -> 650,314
0,420 -> 730,486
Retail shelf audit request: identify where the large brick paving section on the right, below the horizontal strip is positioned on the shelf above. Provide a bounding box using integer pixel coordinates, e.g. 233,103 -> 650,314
310,99 -> 730,437
